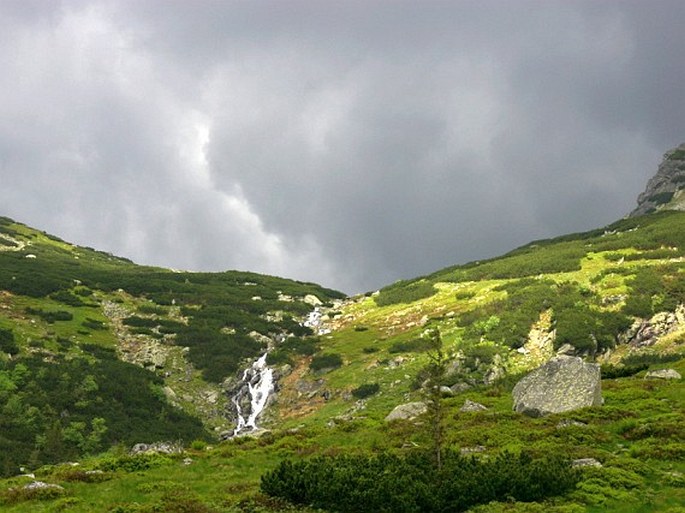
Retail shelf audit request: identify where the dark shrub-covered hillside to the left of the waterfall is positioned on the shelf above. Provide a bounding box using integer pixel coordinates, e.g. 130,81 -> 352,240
0,218 -> 341,475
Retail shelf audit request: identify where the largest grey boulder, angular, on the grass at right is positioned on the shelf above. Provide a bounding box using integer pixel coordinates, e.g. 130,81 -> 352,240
512,356 -> 602,417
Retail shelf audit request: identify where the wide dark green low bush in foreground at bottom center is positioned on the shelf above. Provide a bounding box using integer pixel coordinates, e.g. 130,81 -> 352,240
261,451 -> 580,513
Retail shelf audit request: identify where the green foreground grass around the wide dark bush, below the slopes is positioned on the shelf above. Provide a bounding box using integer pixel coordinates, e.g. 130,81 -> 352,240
0,360 -> 685,512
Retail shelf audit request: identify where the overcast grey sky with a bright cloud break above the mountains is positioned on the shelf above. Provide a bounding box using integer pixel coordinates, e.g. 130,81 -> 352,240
0,0 -> 685,293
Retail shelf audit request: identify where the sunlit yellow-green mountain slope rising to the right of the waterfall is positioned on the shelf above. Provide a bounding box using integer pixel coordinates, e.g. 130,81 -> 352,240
272,212 -> 685,423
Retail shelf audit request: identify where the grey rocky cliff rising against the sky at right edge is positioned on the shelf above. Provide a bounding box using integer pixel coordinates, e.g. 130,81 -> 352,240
629,143 -> 685,217
